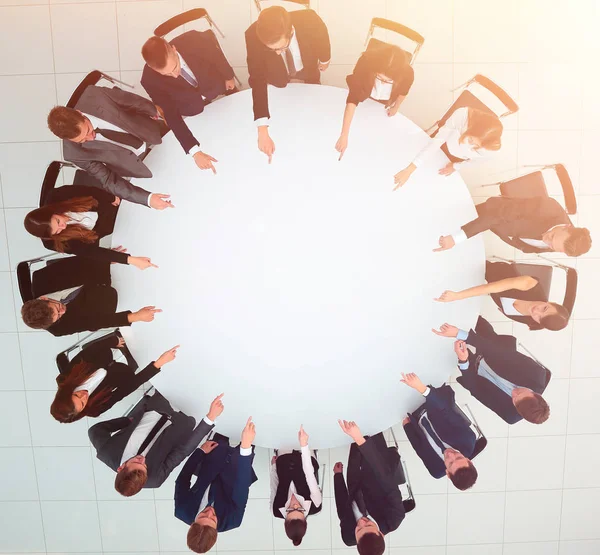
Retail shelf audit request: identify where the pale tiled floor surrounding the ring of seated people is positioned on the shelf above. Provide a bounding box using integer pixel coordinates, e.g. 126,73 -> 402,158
0,0 -> 600,555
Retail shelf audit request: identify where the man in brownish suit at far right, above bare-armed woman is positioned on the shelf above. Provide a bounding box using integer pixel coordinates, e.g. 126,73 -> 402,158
435,197 -> 592,256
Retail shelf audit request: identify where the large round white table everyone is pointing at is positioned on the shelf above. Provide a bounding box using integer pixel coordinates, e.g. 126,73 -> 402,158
112,84 -> 484,448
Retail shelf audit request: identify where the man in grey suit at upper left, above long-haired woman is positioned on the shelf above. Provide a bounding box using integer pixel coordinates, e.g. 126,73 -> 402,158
48,86 -> 172,210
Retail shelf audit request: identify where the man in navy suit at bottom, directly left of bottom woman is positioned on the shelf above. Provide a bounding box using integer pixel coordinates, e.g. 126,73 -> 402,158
175,417 -> 258,553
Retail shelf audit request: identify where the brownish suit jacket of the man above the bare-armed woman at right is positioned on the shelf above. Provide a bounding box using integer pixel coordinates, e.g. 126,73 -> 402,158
462,197 -> 571,253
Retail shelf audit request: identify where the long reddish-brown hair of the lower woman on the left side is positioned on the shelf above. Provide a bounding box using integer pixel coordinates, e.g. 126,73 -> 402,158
50,361 -> 111,423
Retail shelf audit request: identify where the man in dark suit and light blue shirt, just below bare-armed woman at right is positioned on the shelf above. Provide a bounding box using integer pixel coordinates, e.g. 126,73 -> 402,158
433,316 -> 550,424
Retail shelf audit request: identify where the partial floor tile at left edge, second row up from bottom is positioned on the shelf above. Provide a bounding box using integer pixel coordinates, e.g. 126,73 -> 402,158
0,447 -> 39,501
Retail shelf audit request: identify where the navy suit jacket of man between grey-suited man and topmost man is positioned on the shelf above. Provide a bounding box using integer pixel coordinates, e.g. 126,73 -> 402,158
142,31 -> 233,152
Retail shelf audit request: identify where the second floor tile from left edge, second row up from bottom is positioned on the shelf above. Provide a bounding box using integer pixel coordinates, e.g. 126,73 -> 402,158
34,450 -> 96,501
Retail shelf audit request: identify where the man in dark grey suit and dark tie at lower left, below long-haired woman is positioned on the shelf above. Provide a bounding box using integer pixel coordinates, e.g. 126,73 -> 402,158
88,391 -> 223,497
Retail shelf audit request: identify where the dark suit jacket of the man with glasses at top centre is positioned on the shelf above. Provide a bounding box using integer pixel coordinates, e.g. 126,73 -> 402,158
246,10 -> 331,120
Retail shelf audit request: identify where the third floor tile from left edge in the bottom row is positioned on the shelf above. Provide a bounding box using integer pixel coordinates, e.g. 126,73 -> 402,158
98,499 -> 158,552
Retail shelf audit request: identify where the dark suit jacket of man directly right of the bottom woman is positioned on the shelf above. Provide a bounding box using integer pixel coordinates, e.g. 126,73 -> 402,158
333,434 -> 405,546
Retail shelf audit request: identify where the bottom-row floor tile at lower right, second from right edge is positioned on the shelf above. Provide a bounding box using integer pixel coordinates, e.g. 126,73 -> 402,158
504,490 -> 562,543
